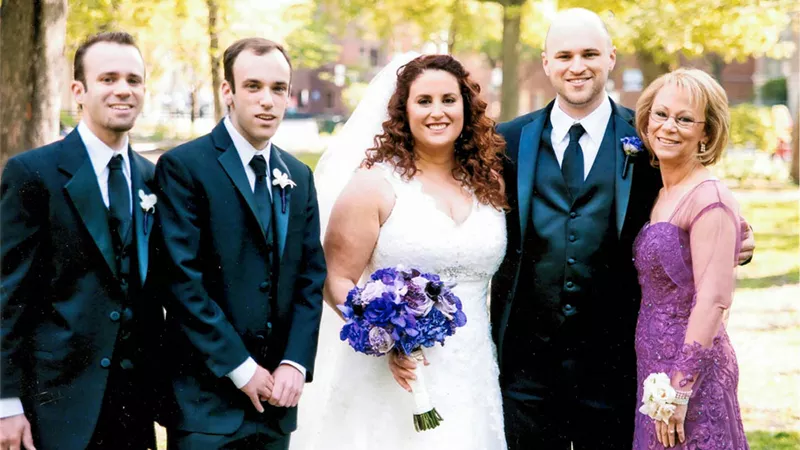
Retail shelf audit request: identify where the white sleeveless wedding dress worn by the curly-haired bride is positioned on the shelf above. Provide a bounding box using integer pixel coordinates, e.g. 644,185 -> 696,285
291,164 -> 506,450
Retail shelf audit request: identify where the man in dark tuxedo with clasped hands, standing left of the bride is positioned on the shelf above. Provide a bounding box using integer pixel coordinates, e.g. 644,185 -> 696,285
150,38 -> 326,449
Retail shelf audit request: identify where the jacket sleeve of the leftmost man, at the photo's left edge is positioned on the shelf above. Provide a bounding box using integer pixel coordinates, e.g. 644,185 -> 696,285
0,159 -> 47,398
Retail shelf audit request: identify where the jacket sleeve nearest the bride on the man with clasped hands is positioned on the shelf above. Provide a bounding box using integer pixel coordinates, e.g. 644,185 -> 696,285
283,169 -> 327,381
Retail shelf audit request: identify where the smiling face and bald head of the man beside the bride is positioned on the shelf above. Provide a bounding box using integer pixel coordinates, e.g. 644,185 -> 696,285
542,16 -> 617,119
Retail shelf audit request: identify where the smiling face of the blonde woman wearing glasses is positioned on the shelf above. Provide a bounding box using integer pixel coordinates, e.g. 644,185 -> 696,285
646,84 -> 708,165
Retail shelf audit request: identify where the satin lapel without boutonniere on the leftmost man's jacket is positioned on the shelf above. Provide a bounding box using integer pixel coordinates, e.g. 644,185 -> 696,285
58,129 -> 117,275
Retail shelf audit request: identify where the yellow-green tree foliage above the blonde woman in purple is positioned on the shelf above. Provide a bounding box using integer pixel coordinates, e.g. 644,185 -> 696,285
559,0 -> 795,83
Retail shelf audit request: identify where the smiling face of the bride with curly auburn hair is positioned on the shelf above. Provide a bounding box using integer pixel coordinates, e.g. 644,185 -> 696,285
406,70 -> 464,155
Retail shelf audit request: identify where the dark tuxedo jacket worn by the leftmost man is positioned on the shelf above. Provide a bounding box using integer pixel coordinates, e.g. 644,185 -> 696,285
0,130 -> 163,449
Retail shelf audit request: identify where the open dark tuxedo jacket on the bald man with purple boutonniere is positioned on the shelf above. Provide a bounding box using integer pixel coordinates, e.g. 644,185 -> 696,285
491,101 -> 661,367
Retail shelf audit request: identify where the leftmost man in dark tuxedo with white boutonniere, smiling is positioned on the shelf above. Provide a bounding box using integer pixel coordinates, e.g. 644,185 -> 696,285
0,32 -> 163,449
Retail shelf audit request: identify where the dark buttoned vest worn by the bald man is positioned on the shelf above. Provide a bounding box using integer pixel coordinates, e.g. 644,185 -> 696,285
515,115 -> 617,340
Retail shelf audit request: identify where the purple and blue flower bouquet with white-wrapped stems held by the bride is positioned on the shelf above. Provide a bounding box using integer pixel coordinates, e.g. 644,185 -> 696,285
339,267 -> 467,431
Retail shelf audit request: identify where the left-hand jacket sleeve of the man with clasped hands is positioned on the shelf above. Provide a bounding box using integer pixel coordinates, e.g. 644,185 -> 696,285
156,153 -> 250,377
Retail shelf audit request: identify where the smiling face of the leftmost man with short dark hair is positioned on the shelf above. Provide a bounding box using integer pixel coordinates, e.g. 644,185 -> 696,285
72,42 -> 145,147
